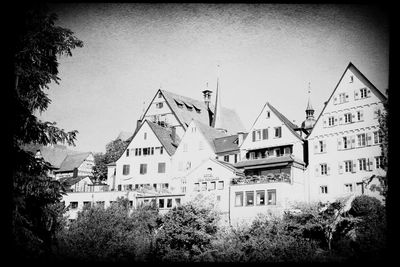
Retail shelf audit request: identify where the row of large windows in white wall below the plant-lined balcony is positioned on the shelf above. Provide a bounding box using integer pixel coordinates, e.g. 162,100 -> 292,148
235,189 -> 276,207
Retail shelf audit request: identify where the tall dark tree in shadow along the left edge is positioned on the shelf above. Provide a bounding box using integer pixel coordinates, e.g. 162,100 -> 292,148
10,3 -> 83,258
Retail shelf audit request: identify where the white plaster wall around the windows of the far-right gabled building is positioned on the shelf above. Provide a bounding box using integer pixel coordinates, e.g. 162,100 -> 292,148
308,69 -> 383,201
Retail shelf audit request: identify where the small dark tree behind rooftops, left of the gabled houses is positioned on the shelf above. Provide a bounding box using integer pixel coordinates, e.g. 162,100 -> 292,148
93,138 -> 132,181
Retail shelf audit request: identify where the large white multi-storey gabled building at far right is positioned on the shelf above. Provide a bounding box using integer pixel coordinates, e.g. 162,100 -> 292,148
308,63 -> 386,204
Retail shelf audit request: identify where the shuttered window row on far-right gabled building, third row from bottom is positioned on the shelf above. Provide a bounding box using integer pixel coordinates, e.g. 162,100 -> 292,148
314,131 -> 383,154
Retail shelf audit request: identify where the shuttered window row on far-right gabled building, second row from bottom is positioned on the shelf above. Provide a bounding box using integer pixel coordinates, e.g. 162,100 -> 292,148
315,156 -> 384,176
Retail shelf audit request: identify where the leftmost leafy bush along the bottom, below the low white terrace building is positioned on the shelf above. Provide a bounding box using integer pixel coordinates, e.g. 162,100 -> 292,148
58,198 -> 160,262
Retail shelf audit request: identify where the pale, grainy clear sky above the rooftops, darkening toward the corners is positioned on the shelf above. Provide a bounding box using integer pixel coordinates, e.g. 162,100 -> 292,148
39,3 -> 389,153
